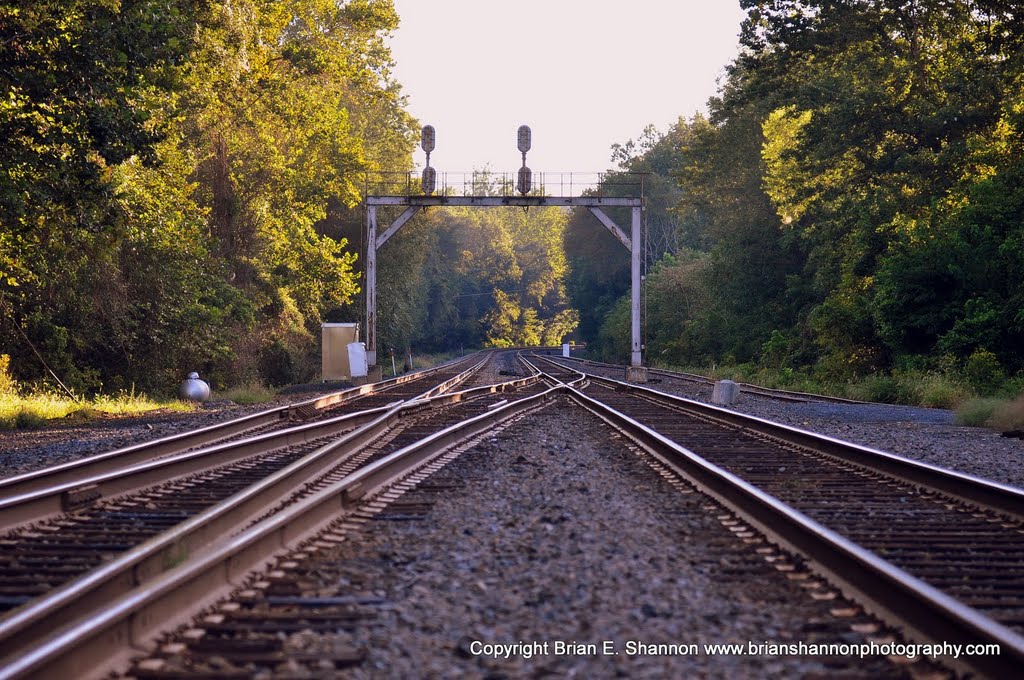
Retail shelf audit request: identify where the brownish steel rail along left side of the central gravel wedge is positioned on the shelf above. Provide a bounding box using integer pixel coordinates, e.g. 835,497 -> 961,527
0,386 -> 565,680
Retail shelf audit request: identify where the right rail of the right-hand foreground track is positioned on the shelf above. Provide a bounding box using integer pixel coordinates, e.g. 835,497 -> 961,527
577,376 -> 1024,520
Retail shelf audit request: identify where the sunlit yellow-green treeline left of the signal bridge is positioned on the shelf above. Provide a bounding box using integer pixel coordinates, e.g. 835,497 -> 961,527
0,0 -> 415,390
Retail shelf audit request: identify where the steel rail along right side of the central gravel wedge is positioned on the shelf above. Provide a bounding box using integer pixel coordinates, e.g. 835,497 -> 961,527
566,387 -> 1024,678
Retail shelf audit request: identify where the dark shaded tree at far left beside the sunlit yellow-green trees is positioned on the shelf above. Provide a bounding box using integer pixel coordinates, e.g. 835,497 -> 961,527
0,0 -> 209,389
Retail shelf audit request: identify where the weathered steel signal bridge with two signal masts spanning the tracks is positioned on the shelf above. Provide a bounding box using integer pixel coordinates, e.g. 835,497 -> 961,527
366,126 -> 646,382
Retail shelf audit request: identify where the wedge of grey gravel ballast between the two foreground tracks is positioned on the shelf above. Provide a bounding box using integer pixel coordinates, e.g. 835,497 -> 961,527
144,399 -> 942,680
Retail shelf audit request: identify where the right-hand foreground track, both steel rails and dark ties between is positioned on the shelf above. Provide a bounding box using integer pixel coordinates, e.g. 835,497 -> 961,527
528,358 -> 1024,677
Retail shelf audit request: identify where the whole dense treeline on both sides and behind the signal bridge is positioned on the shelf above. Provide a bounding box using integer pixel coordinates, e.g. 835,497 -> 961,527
8,0 -> 1024,399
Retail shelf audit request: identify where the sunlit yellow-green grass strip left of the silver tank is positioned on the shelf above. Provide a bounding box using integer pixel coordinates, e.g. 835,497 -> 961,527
0,390 -> 196,430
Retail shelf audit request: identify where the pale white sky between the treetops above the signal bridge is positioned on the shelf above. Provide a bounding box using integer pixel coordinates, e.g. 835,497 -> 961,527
389,0 -> 743,173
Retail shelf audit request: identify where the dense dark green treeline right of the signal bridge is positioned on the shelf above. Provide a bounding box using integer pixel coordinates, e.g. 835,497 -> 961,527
566,0 -> 1024,389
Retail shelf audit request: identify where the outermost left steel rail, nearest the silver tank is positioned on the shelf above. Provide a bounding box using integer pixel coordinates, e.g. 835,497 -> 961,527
0,355 -> 491,498
